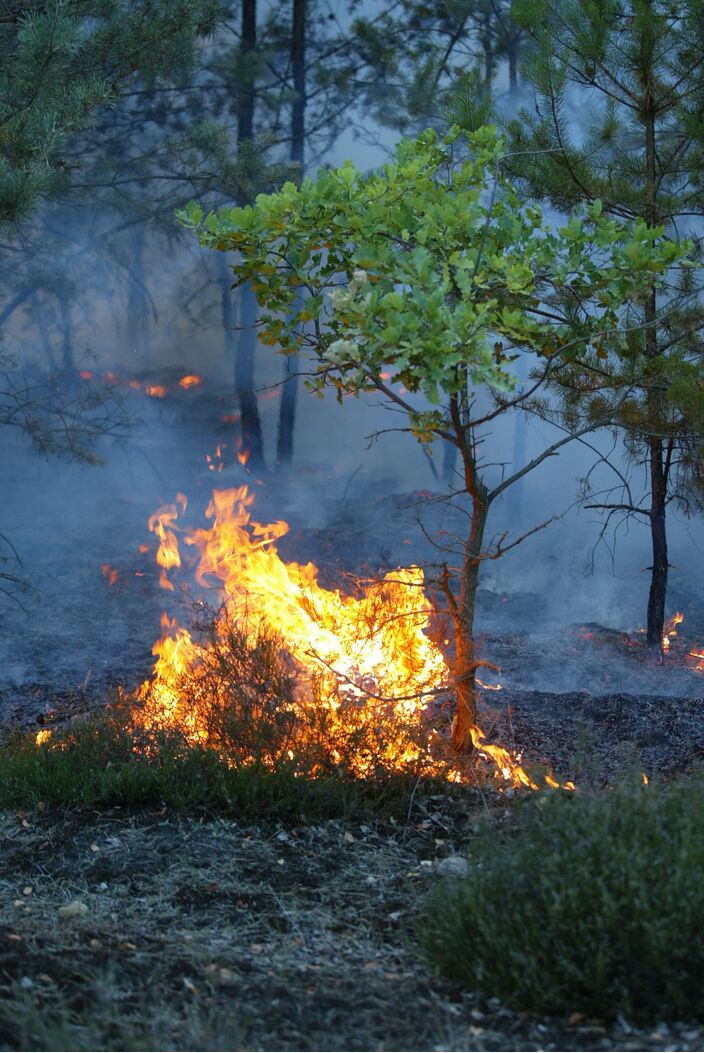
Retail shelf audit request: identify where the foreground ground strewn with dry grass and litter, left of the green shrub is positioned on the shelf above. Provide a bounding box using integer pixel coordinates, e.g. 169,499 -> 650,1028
0,792 -> 704,1050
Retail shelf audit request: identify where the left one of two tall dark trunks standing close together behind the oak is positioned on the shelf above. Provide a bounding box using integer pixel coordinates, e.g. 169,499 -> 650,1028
234,0 -> 266,472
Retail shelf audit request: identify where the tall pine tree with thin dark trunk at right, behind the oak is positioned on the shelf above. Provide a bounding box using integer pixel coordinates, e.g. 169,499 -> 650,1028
509,0 -> 704,653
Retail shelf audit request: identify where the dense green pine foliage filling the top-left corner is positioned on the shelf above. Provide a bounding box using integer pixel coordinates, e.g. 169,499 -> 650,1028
0,0 -> 218,224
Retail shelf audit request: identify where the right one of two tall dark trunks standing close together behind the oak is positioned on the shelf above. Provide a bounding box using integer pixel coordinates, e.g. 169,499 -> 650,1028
277,0 -> 307,465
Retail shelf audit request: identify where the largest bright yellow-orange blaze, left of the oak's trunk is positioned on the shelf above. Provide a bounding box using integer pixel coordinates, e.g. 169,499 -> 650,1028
136,485 -> 571,789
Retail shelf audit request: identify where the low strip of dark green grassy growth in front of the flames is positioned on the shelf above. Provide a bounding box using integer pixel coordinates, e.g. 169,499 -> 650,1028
0,706 -> 410,821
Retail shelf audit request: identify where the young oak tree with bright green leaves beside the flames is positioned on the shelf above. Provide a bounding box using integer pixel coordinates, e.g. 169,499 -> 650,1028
180,126 -> 683,750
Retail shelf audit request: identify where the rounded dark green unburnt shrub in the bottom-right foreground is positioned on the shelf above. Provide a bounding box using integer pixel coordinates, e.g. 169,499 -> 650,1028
420,776 -> 704,1022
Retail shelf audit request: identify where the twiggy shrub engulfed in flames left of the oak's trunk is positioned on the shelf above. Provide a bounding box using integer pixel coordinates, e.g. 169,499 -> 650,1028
135,607 -> 439,778
